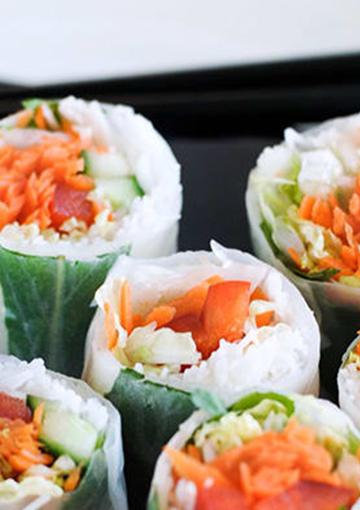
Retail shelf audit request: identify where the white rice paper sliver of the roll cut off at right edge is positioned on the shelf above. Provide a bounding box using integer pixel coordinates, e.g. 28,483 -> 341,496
338,337 -> 360,428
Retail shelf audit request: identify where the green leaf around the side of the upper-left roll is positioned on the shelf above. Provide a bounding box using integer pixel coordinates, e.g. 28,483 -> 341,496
0,247 -> 128,377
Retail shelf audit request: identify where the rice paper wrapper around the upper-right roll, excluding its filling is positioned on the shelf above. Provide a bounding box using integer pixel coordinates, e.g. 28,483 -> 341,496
246,115 -> 360,392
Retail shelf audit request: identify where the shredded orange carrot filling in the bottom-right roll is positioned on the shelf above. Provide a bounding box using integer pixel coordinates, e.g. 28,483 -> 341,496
169,418 -> 341,502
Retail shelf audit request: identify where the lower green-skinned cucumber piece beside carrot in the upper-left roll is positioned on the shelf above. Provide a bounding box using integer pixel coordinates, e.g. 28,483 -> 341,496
95,176 -> 144,209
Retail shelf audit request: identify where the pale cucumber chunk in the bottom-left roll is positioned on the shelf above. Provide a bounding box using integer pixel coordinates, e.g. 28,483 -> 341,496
27,395 -> 98,464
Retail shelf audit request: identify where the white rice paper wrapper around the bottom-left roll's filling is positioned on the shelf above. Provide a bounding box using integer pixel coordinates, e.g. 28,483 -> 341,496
0,356 -> 127,510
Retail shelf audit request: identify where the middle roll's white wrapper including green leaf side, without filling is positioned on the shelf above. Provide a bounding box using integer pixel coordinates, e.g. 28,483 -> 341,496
83,242 -> 320,505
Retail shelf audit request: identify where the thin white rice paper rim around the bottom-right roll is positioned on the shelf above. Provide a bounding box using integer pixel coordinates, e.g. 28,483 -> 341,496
147,387 -> 360,510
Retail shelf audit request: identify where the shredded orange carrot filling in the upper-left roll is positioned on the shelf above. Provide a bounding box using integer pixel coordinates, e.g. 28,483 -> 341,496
0,133 -> 101,230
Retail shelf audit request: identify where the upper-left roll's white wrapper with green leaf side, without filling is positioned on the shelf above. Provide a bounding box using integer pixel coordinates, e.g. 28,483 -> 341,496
0,97 -> 182,376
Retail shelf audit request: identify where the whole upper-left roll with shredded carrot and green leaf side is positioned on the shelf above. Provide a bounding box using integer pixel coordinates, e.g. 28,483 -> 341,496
0,97 -> 181,375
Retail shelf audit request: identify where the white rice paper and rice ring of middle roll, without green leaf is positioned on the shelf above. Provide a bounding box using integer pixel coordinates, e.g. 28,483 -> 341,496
84,242 -> 320,399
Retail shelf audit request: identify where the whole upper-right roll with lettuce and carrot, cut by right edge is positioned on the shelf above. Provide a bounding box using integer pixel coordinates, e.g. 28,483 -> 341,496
246,115 -> 360,386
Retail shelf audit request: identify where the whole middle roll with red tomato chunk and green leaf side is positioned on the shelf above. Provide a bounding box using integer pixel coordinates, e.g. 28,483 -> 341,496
84,243 -> 320,508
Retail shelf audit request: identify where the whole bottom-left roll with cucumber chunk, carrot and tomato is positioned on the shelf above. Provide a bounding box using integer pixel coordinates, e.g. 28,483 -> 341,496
0,356 -> 127,510
